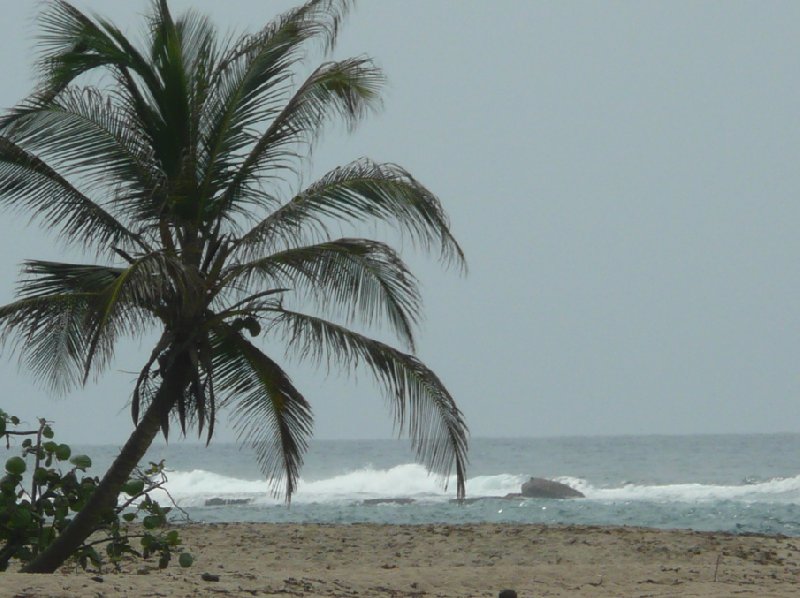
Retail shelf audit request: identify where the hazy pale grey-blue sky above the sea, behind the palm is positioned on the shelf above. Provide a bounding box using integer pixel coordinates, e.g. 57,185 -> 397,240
0,0 -> 800,443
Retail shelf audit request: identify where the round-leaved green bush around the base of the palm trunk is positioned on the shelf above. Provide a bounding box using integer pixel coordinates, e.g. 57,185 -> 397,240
0,409 -> 192,571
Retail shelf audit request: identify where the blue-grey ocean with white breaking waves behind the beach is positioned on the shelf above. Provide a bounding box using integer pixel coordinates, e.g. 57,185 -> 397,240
6,434 -> 800,536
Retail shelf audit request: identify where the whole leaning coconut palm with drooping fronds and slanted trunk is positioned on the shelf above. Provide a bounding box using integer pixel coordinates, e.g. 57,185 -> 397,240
0,0 -> 467,572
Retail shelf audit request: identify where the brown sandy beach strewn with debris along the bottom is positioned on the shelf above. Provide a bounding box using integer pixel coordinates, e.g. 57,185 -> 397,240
0,523 -> 800,598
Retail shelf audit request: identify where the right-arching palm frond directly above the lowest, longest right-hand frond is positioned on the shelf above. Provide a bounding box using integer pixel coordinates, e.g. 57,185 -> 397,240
223,239 -> 422,351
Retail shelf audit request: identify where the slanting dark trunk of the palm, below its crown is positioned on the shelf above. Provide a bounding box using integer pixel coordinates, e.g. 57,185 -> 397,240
22,359 -> 189,573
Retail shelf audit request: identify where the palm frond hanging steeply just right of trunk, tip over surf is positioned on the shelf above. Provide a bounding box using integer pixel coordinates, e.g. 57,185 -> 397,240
210,325 -> 312,500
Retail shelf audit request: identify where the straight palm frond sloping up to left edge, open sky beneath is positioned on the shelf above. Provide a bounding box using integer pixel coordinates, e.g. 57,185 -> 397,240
0,137 -> 147,252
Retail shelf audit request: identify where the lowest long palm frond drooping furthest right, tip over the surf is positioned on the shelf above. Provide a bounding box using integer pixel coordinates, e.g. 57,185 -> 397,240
271,310 -> 468,499
